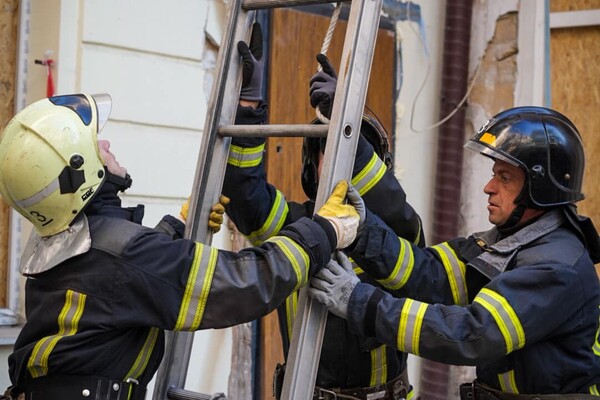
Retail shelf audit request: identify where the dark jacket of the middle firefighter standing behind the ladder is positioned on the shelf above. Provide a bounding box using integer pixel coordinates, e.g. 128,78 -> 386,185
223,103 -> 424,388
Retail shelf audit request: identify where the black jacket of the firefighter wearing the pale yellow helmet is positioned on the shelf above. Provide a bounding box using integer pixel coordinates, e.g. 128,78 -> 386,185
9,180 -> 335,393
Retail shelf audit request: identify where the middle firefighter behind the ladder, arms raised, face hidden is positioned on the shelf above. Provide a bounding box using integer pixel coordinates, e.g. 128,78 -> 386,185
223,22 -> 424,400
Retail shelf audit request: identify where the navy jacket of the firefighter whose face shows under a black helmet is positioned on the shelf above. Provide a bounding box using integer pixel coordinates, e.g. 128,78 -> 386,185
348,208 -> 600,395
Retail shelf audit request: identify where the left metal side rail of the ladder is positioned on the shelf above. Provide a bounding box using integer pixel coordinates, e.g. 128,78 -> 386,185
152,0 -> 255,400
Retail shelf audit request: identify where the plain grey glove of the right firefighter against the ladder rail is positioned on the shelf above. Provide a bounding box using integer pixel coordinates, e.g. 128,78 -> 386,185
308,251 -> 360,319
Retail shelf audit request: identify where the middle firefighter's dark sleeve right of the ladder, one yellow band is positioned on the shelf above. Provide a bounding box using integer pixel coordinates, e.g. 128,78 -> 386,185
352,135 -> 425,246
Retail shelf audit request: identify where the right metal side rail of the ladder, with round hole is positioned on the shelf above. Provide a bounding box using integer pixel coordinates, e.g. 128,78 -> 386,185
281,0 -> 382,400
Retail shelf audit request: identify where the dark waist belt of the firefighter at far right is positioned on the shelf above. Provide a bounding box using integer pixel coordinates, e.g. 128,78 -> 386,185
460,381 -> 598,400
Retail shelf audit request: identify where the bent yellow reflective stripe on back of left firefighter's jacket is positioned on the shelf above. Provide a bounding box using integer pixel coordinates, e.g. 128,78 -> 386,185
27,290 -> 87,378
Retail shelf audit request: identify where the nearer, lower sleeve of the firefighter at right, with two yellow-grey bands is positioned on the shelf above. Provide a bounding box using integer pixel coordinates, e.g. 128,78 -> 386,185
348,250 -> 597,365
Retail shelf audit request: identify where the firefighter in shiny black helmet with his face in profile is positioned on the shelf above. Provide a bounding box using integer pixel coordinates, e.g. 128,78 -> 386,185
309,107 -> 600,400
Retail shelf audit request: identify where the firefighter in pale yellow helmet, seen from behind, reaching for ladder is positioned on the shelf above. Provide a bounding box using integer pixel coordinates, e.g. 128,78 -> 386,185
0,42 -> 364,400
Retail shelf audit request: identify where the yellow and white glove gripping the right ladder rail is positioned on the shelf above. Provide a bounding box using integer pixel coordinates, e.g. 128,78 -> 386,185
317,180 -> 366,249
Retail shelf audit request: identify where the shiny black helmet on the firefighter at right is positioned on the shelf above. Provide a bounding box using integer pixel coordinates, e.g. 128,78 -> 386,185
465,107 -> 585,208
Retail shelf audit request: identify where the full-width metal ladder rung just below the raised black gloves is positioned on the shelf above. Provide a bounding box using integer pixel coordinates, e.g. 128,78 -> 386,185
218,124 -> 329,137
